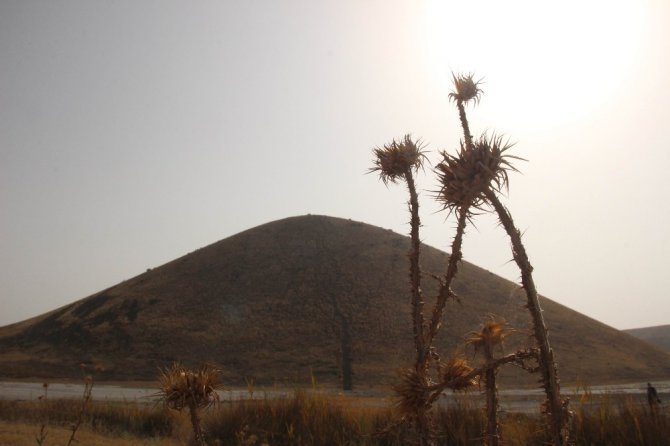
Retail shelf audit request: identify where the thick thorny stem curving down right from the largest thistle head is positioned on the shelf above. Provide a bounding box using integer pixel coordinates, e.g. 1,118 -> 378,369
486,189 -> 568,446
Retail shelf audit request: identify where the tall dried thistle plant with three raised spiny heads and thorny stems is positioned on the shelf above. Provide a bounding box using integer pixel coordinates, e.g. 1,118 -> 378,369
370,74 -> 568,445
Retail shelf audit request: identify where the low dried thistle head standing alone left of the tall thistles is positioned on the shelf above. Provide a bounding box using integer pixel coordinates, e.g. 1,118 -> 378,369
158,363 -> 219,411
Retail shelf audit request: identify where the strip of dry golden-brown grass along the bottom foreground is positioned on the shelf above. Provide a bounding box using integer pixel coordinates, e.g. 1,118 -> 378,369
0,391 -> 670,446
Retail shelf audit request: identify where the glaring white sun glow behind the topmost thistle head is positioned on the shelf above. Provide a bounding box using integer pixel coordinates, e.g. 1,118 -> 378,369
424,0 -> 645,129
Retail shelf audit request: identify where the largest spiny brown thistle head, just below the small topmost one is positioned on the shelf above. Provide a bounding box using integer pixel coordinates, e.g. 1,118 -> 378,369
435,133 -> 522,212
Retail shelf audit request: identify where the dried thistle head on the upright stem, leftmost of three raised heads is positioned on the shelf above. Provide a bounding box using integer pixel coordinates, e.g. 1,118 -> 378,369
370,135 -> 426,185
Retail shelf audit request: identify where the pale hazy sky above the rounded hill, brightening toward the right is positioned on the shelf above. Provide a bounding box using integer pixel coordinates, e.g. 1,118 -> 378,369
0,0 -> 670,328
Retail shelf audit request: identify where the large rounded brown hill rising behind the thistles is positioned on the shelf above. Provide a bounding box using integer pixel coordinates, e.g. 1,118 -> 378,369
0,215 -> 670,385
